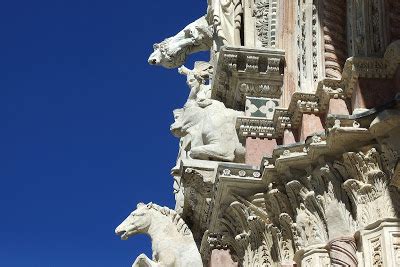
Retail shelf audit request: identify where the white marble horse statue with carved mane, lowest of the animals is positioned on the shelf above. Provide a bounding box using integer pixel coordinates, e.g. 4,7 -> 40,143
115,203 -> 203,267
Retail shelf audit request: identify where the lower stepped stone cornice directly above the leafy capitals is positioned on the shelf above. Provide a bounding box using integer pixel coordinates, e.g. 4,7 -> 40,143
209,99 -> 400,245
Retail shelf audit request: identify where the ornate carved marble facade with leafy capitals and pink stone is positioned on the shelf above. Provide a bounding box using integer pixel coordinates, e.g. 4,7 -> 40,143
116,0 -> 400,267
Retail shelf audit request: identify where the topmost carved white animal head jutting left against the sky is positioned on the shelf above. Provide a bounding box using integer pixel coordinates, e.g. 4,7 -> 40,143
148,17 -> 212,69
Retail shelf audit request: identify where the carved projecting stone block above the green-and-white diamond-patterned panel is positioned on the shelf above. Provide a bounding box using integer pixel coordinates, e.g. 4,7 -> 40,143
212,46 -> 285,110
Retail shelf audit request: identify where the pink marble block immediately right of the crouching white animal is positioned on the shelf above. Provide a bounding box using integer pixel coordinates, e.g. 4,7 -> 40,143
245,137 -> 277,166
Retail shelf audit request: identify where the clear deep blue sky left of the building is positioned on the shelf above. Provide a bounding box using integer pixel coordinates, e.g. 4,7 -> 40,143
0,0 -> 207,267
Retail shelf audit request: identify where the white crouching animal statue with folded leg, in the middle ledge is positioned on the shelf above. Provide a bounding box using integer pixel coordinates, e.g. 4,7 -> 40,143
171,100 -> 245,162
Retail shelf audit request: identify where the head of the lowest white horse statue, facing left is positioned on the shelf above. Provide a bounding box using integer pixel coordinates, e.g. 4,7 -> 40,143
115,203 -> 152,240
